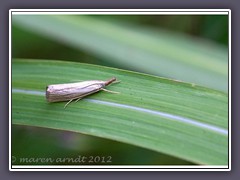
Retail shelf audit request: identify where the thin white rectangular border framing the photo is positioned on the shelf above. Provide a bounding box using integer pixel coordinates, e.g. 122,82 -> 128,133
9,9 -> 231,171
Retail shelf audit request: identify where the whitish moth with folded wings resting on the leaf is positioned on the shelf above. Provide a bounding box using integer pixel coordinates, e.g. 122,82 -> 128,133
46,77 -> 119,108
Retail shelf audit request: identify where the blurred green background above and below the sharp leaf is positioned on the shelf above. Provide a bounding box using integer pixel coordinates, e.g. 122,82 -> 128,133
12,15 -> 228,165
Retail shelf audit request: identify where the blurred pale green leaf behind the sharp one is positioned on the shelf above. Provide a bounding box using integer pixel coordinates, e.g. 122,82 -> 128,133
12,15 -> 228,92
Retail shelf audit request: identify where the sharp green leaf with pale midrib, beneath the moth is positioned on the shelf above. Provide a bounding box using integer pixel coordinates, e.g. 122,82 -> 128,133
12,59 -> 228,165
